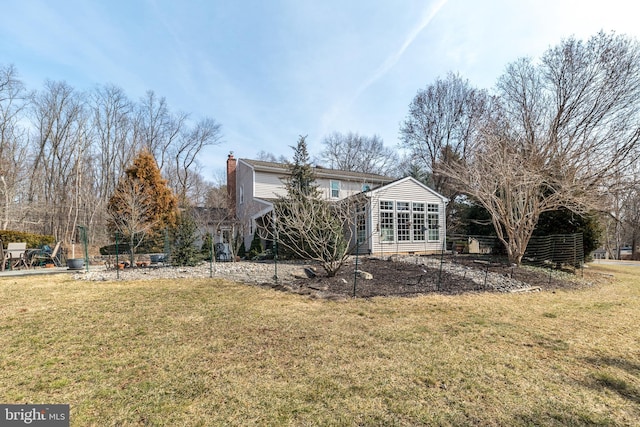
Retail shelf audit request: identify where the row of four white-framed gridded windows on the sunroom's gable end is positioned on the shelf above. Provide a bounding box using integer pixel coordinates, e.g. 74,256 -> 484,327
380,200 -> 440,242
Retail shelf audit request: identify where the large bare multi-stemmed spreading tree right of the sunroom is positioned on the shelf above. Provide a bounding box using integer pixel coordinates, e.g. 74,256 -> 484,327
438,33 -> 640,264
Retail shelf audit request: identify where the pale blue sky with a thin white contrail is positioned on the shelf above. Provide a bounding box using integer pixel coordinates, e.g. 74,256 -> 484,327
0,0 -> 640,180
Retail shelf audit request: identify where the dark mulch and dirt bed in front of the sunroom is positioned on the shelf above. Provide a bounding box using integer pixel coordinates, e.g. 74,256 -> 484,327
282,257 -> 592,298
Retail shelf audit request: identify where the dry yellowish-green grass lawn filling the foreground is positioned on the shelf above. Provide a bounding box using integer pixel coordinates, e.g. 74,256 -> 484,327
0,265 -> 640,426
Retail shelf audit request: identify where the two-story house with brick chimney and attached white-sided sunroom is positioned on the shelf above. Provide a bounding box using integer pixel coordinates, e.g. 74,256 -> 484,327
227,154 -> 447,255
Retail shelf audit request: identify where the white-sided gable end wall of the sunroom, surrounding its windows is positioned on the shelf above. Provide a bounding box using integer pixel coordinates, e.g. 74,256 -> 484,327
369,179 -> 446,254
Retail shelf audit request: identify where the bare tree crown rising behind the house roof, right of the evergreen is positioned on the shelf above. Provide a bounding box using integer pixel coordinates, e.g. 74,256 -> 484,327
318,132 -> 398,176
